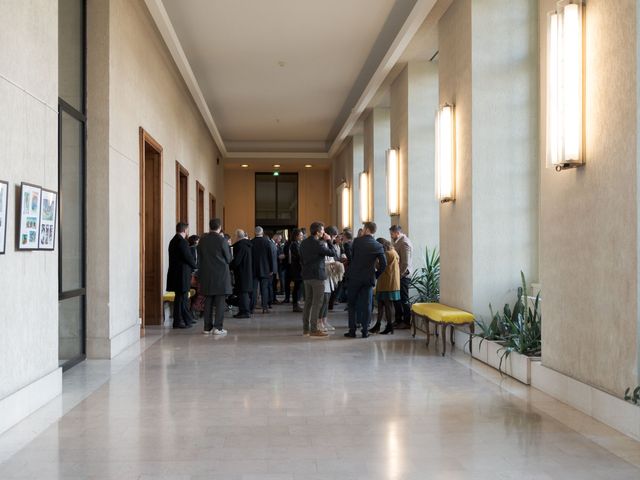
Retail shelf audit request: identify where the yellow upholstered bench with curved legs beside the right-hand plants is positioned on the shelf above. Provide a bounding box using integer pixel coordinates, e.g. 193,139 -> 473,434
411,303 -> 475,356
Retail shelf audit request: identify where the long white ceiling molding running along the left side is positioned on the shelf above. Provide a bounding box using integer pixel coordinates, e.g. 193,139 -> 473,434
145,0 -> 228,157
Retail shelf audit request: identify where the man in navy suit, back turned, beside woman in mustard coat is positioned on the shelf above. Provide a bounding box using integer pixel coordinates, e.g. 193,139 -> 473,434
344,222 -> 387,338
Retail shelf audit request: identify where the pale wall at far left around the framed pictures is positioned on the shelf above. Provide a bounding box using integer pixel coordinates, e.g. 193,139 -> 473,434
0,0 -> 62,432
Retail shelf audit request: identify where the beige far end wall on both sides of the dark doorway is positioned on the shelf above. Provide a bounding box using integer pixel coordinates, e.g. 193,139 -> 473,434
224,168 -> 331,235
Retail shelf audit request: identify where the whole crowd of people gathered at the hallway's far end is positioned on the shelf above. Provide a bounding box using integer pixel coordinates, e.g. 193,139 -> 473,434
167,219 -> 413,338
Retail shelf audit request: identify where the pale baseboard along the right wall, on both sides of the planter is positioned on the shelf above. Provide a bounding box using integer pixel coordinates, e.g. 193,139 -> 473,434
455,329 -> 640,441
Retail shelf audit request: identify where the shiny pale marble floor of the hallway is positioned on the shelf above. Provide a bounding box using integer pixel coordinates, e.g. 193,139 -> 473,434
0,307 -> 640,480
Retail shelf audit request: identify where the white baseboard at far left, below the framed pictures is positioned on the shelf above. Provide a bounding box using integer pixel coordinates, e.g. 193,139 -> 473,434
0,368 -> 62,433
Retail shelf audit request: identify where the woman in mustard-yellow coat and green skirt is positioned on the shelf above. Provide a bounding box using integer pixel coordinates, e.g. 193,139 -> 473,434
369,238 -> 400,335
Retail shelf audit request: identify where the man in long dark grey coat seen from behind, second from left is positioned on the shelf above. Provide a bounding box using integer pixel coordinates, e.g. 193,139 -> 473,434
198,218 -> 231,335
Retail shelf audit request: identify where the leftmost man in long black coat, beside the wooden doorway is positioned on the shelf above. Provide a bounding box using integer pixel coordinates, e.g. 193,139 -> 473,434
167,222 -> 196,328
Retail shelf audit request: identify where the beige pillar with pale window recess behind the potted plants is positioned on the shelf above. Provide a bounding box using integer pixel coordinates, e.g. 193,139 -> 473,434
438,0 -> 539,320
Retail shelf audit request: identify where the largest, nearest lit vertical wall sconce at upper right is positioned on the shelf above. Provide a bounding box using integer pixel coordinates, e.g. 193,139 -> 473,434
547,0 -> 583,171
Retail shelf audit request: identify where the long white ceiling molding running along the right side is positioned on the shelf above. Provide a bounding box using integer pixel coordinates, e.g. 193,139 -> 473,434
328,0 -> 436,157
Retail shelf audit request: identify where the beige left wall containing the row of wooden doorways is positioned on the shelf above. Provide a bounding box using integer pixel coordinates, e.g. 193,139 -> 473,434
87,0 -> 223,357
